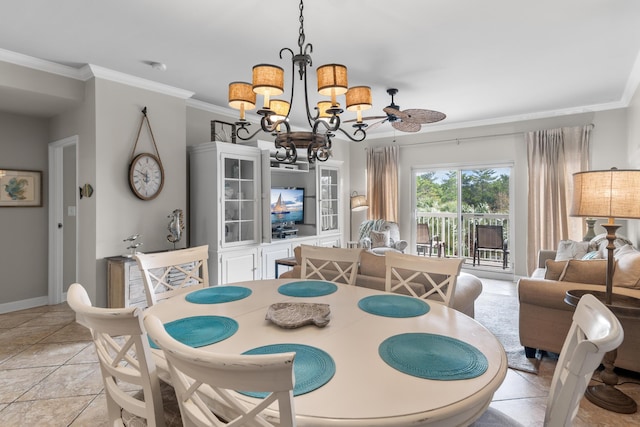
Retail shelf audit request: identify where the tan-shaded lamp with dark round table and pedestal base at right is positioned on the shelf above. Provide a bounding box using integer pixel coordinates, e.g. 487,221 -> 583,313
565,168 -> 640,414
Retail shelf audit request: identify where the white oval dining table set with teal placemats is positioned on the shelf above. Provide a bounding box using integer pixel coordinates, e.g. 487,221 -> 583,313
147,279 -> 507,427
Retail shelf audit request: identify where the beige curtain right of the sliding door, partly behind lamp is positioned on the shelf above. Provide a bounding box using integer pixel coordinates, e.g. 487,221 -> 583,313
525,125 -> 593,274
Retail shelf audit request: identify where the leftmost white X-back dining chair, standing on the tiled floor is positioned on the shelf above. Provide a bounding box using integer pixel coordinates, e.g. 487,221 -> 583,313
67,283 -> 182,427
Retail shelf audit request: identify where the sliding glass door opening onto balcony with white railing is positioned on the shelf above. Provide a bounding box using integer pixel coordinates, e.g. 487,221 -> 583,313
412,165 -> 512,269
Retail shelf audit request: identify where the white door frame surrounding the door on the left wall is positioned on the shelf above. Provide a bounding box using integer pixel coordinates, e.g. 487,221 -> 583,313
48,135 -> 79,305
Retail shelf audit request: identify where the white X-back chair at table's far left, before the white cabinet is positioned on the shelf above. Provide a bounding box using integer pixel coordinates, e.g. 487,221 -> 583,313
134,245 -> 209,307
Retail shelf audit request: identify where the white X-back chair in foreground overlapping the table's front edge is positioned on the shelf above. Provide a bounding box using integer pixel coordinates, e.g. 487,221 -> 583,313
144,314 -> 296,427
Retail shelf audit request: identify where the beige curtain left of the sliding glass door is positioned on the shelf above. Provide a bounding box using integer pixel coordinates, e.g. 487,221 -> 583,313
367,147 -> 398,222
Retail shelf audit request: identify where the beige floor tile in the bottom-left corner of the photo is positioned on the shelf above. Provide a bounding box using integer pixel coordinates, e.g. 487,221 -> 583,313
0,396 -> 93,427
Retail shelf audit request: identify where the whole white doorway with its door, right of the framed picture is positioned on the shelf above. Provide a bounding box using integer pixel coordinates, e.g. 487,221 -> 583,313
48,136 -> 79,305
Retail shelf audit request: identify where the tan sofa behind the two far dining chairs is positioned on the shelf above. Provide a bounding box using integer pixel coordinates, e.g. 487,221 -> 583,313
280,246 -> 482,317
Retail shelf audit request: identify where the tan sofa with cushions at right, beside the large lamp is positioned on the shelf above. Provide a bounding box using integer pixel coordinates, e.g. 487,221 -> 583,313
518,250 -> 640,372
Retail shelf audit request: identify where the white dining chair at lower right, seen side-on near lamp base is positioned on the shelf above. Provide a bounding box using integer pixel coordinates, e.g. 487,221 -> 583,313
473,294 -> 624,427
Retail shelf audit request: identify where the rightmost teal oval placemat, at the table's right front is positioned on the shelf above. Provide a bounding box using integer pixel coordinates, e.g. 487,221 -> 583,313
378,333 -> 489,380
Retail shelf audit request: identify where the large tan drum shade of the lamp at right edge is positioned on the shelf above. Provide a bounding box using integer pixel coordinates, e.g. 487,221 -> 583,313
571,168 -> 640,218
